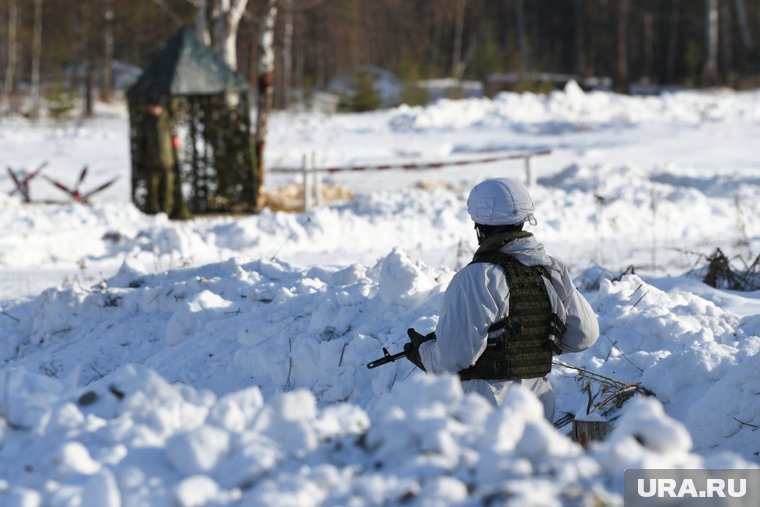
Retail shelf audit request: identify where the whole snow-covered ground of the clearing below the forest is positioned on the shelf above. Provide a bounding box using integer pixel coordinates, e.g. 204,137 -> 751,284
0,84 -> 760,507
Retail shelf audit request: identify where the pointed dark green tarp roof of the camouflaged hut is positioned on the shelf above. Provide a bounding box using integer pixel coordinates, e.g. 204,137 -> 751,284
127,26 -> 248,100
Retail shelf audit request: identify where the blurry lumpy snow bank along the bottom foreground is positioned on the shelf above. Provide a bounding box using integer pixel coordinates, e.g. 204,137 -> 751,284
0,365 -> 752,507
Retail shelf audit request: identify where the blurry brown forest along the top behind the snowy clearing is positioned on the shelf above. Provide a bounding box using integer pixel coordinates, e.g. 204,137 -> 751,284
0,0 -> 760,117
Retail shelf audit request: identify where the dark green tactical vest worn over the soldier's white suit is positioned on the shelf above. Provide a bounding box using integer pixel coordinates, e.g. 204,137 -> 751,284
459,232 -> 565,380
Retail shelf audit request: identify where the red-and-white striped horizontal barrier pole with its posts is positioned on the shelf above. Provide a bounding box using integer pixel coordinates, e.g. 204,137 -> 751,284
269,150 -> 551,210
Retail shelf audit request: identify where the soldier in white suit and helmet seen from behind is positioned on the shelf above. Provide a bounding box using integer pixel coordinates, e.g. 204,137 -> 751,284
404,178 -> 599,420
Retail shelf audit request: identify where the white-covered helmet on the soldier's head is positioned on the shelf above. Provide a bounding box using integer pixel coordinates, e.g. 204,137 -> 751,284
467,178 -> 536,225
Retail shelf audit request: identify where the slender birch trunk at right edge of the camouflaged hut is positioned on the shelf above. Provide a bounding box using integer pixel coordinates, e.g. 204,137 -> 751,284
256,0 -> 277,194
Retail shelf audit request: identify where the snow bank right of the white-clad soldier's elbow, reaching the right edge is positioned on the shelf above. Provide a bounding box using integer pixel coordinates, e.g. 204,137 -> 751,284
554,275 -> 760,461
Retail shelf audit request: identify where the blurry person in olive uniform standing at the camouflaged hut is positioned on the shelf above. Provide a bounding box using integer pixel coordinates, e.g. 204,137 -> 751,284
142,99 -> 175,214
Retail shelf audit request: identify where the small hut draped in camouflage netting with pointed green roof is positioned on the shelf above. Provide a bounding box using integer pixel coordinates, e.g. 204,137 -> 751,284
127,27 -> 259,218
